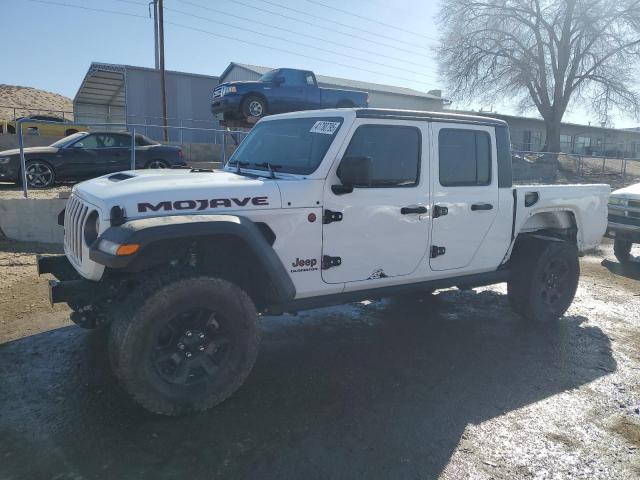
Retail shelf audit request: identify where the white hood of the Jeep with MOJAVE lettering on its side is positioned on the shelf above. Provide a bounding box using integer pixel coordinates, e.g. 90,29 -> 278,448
73,169 -> 281,218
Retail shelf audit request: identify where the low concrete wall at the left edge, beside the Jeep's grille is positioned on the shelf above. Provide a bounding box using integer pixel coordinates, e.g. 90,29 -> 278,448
0,198 -> 67,243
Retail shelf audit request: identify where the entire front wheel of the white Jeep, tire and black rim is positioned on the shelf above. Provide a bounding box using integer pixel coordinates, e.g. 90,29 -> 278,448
109,277 -> 259,415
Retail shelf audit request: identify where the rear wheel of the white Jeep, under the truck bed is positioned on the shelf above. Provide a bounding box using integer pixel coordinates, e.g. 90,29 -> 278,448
507,239 -> 580,323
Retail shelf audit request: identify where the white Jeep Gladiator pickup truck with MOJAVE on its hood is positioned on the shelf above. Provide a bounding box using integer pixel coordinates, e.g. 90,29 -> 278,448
38,109 -> 609,415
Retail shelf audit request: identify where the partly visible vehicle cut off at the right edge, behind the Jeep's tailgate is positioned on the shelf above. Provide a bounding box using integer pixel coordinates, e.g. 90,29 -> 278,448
607,183 -> 640,264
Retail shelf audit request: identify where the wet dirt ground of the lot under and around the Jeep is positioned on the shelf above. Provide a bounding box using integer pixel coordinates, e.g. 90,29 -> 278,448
0,240 -> 640,480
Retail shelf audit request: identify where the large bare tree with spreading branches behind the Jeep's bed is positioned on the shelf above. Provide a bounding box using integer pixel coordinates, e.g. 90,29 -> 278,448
438,0 -> 640,152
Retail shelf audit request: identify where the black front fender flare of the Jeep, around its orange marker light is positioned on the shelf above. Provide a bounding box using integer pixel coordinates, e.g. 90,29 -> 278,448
90,215 -> 296,307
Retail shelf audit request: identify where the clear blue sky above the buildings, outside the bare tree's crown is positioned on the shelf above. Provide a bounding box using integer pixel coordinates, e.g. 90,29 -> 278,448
0,0 -> 637,127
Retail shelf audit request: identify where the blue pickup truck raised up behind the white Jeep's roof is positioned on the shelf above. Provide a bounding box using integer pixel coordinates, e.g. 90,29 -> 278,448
211,68 -> 369,123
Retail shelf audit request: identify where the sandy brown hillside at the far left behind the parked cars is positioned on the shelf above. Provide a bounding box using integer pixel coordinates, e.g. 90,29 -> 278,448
0,84 -> 73,120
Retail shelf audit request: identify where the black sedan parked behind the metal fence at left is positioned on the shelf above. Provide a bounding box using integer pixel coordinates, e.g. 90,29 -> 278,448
0,132 -> 186,188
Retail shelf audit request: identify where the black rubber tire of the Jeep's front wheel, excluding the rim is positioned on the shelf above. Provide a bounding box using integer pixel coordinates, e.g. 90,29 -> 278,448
109,277 -> 259,416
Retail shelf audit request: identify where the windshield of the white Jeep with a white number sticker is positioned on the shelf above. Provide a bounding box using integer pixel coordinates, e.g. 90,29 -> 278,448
228,117 -> 343,175
